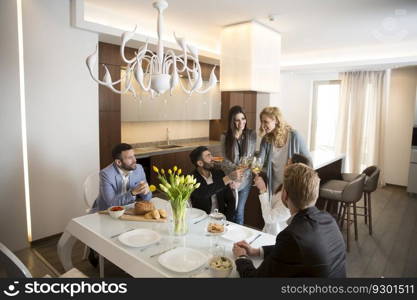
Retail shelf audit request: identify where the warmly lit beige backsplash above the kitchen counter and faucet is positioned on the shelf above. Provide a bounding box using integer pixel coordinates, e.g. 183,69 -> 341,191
122,121 -> 209,145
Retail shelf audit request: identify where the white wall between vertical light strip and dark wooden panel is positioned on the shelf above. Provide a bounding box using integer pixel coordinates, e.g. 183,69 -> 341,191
22,0 -> 99,240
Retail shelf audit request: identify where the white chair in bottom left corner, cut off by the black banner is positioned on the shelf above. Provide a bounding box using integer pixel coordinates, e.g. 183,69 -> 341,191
0,242 -> 87,278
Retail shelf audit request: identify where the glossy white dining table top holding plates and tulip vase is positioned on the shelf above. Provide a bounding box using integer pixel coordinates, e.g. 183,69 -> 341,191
66,198 -> 275,277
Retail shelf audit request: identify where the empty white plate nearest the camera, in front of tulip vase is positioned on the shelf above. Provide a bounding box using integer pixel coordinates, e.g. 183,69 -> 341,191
158,247 -> 209,273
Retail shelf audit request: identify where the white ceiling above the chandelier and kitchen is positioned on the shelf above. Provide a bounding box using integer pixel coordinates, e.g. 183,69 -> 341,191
85,0 -> 417,67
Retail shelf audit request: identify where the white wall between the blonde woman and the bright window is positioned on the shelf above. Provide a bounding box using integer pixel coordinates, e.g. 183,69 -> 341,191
271,72 -> 339,145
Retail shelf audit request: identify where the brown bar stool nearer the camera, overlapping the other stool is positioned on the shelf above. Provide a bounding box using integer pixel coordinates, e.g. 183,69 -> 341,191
320,174 -> 366,252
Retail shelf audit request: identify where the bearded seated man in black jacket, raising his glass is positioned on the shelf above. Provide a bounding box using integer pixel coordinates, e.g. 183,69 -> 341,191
190,146 -> 243,220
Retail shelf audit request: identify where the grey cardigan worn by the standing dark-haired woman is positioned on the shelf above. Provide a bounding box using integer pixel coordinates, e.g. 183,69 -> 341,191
220,129 -> 256,191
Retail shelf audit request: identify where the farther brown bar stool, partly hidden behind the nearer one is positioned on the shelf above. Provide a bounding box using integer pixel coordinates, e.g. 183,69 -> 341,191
342,166 -> 381,235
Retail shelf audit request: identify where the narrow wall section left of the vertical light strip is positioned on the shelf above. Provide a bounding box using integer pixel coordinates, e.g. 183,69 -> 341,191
0,1 -> 28,251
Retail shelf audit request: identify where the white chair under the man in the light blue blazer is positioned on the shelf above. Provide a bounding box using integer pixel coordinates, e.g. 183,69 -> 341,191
83,172 -> 104,278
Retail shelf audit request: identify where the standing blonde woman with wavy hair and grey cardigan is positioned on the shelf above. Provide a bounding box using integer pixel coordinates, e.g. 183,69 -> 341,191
259,106 -> 311,199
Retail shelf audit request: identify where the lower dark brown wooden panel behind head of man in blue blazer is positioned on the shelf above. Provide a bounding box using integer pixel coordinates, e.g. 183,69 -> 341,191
99,112 -> 121,168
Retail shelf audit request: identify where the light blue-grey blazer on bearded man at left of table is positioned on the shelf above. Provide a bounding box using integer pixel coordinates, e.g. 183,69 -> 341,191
92,163 -> 152,211
